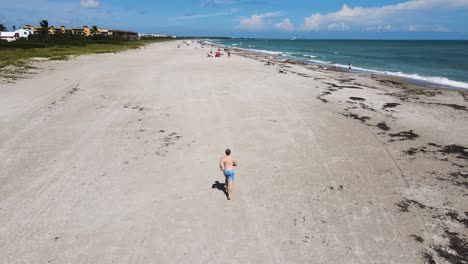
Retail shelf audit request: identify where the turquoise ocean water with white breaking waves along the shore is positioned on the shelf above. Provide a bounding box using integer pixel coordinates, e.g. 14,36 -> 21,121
211,39 -> 468,89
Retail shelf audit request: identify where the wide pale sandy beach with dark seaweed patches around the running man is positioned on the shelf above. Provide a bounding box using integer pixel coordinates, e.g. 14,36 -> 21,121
0,41 -> 468,263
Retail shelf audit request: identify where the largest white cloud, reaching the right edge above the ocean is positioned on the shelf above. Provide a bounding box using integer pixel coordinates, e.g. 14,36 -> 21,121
298,0 -> 468,31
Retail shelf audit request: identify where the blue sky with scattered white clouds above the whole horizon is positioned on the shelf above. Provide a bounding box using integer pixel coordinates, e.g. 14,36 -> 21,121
0,0 -> 468,39
